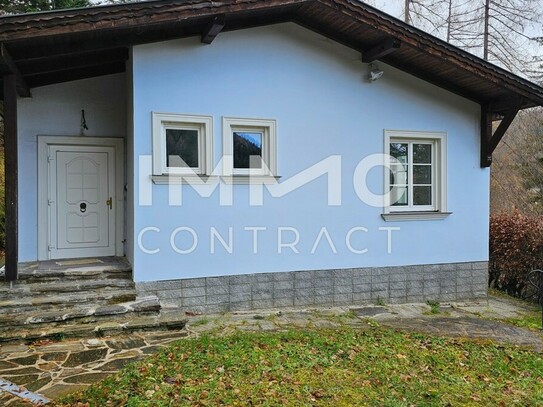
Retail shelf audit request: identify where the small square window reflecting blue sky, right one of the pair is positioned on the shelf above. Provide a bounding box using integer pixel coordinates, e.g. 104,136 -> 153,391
223,117 -> 277,177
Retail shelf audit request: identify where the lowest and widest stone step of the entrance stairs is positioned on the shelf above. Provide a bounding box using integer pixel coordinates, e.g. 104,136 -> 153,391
0,311 -> 187,342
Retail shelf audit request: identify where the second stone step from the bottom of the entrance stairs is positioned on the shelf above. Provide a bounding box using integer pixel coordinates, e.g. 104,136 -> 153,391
0,296 -> 160,337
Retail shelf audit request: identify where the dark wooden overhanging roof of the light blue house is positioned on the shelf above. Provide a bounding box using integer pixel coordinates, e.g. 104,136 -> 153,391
0,0 -> 543,113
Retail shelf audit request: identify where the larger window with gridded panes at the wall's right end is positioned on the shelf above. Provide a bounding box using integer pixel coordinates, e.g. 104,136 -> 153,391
383,131 -> 449,220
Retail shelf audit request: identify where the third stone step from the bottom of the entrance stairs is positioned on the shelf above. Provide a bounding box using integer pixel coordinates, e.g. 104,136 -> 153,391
0,289 -> 136,315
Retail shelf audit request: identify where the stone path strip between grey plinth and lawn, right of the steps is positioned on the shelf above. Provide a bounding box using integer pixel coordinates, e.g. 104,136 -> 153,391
184,297 -> 543,352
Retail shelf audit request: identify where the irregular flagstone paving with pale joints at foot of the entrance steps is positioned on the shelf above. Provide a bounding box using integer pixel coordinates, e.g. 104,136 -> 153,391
0,330 -> 187,406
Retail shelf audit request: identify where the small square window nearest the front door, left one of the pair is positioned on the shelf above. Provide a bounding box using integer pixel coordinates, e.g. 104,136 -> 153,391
153,113 -> 213,175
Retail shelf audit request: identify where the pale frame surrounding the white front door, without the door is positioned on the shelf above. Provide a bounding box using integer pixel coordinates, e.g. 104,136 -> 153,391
37,135 -> 125,260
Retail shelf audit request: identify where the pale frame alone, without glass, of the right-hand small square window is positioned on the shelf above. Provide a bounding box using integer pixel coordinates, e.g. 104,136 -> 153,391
222,117 -> 277,181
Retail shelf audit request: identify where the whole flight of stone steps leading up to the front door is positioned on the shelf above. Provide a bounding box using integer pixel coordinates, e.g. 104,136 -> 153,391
0,257 -> 170,341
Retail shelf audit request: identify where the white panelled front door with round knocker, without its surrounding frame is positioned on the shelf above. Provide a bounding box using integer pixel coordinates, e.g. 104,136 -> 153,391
49,146 -> 116,259
